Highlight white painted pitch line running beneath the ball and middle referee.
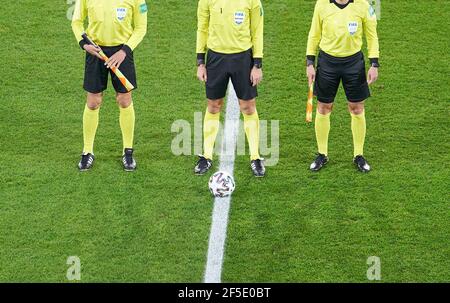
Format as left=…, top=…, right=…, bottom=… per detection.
left=204, top=81, right=240, bottom=283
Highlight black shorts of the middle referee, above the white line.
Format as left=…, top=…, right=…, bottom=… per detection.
left=206, top=49, right=258, bottom=100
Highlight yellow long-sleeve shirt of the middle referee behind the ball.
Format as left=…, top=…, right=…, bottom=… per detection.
left=197, top=0, right=264, bottom=58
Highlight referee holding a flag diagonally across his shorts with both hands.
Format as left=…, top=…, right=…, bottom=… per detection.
left=72, top=0, right=147, bottom=171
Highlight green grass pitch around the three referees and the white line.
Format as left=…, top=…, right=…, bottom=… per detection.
left=0, top=0, right=450, bottom=282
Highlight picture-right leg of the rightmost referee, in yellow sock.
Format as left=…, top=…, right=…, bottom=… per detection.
left=348, top=101, right=366, bottom=157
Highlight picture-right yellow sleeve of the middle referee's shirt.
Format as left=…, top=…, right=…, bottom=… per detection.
left=250, top=0, right=264, bottom=58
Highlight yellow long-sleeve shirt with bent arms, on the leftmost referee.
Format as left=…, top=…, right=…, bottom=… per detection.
left=72, top=0, right=147, bottom=50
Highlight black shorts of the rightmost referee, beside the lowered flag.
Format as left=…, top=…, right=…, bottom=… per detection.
left=314, top=51, right=370, bottom=103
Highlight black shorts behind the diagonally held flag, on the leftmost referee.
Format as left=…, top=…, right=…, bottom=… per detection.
left=83, top=45, right=137, bottom=94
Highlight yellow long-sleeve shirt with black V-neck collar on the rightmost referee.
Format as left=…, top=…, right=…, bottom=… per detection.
left=306, top=0, right=380, bottom=58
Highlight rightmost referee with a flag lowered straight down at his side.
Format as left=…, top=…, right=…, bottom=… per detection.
left=306, top=0, right=379, bottom=172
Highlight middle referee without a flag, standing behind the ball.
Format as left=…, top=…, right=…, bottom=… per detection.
left=194, top=0, right=265, bottom=177
